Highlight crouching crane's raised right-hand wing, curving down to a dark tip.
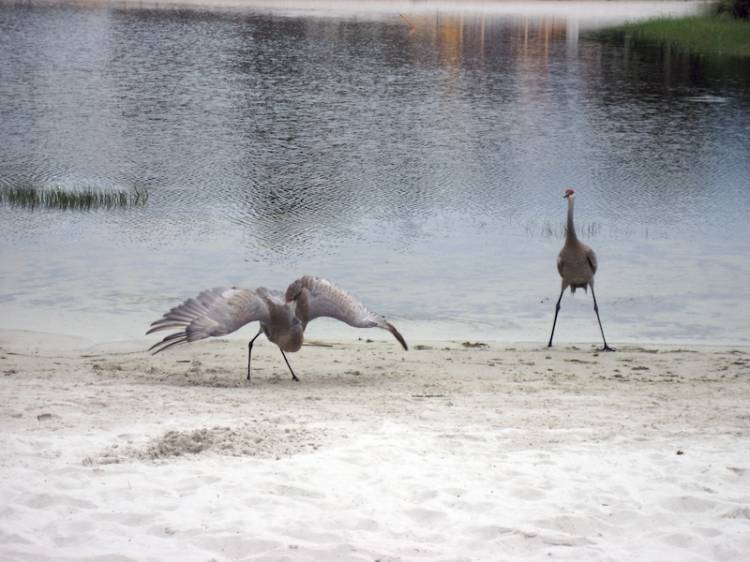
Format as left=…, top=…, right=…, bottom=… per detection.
left=289, top=275, right=409, bottom=349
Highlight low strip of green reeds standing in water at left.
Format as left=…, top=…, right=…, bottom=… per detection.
left=0, top=184, right=148, bottom=211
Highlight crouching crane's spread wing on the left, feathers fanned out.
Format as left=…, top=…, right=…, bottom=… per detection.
left=146, top=287, right=269, bottom=354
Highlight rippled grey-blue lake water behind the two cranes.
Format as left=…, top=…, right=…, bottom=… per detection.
left=0, top=1, right=750, bottom=345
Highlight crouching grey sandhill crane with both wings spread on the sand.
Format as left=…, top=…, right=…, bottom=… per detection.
left=146, top=275, right=409, bottom=381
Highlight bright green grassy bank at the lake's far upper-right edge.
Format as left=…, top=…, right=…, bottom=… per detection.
left=601, top=15, right=750, bottom=57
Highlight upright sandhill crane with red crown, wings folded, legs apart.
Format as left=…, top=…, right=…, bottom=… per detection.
left=547, top=189, right=614, bottom=351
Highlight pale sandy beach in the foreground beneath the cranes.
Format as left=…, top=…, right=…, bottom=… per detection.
left=0, top=338, right=750, bottom=561
